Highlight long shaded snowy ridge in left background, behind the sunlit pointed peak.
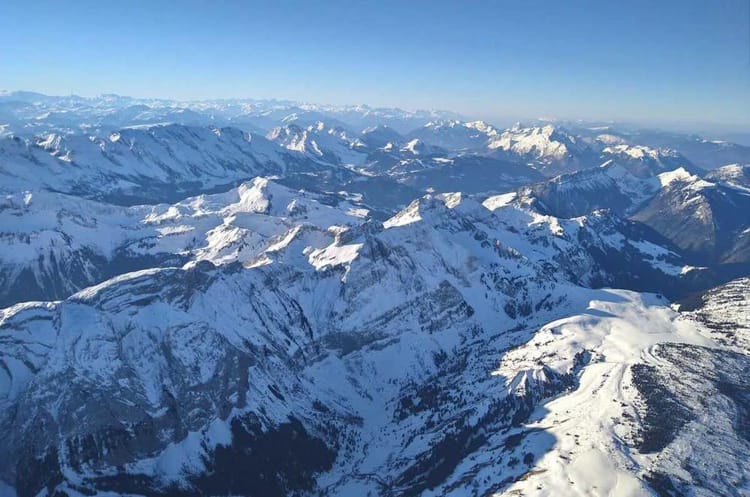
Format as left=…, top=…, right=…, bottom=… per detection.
left=0, top=121, right=426, bottom=218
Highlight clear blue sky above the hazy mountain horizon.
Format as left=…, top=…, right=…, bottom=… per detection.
left=0, top=0, right=750, bottom=126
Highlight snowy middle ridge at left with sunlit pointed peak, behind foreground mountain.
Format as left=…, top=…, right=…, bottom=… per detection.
left=0, top=178, right=368, bottom=307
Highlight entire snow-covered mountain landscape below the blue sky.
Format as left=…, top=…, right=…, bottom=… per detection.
left=0, top=92, right=750, bottom=497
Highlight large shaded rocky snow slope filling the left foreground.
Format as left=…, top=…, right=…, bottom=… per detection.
left=0, top=191, right=596, bottom=495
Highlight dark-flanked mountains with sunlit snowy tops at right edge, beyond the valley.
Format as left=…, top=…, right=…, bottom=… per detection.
left=516, top=161, right=750, bottom=275
